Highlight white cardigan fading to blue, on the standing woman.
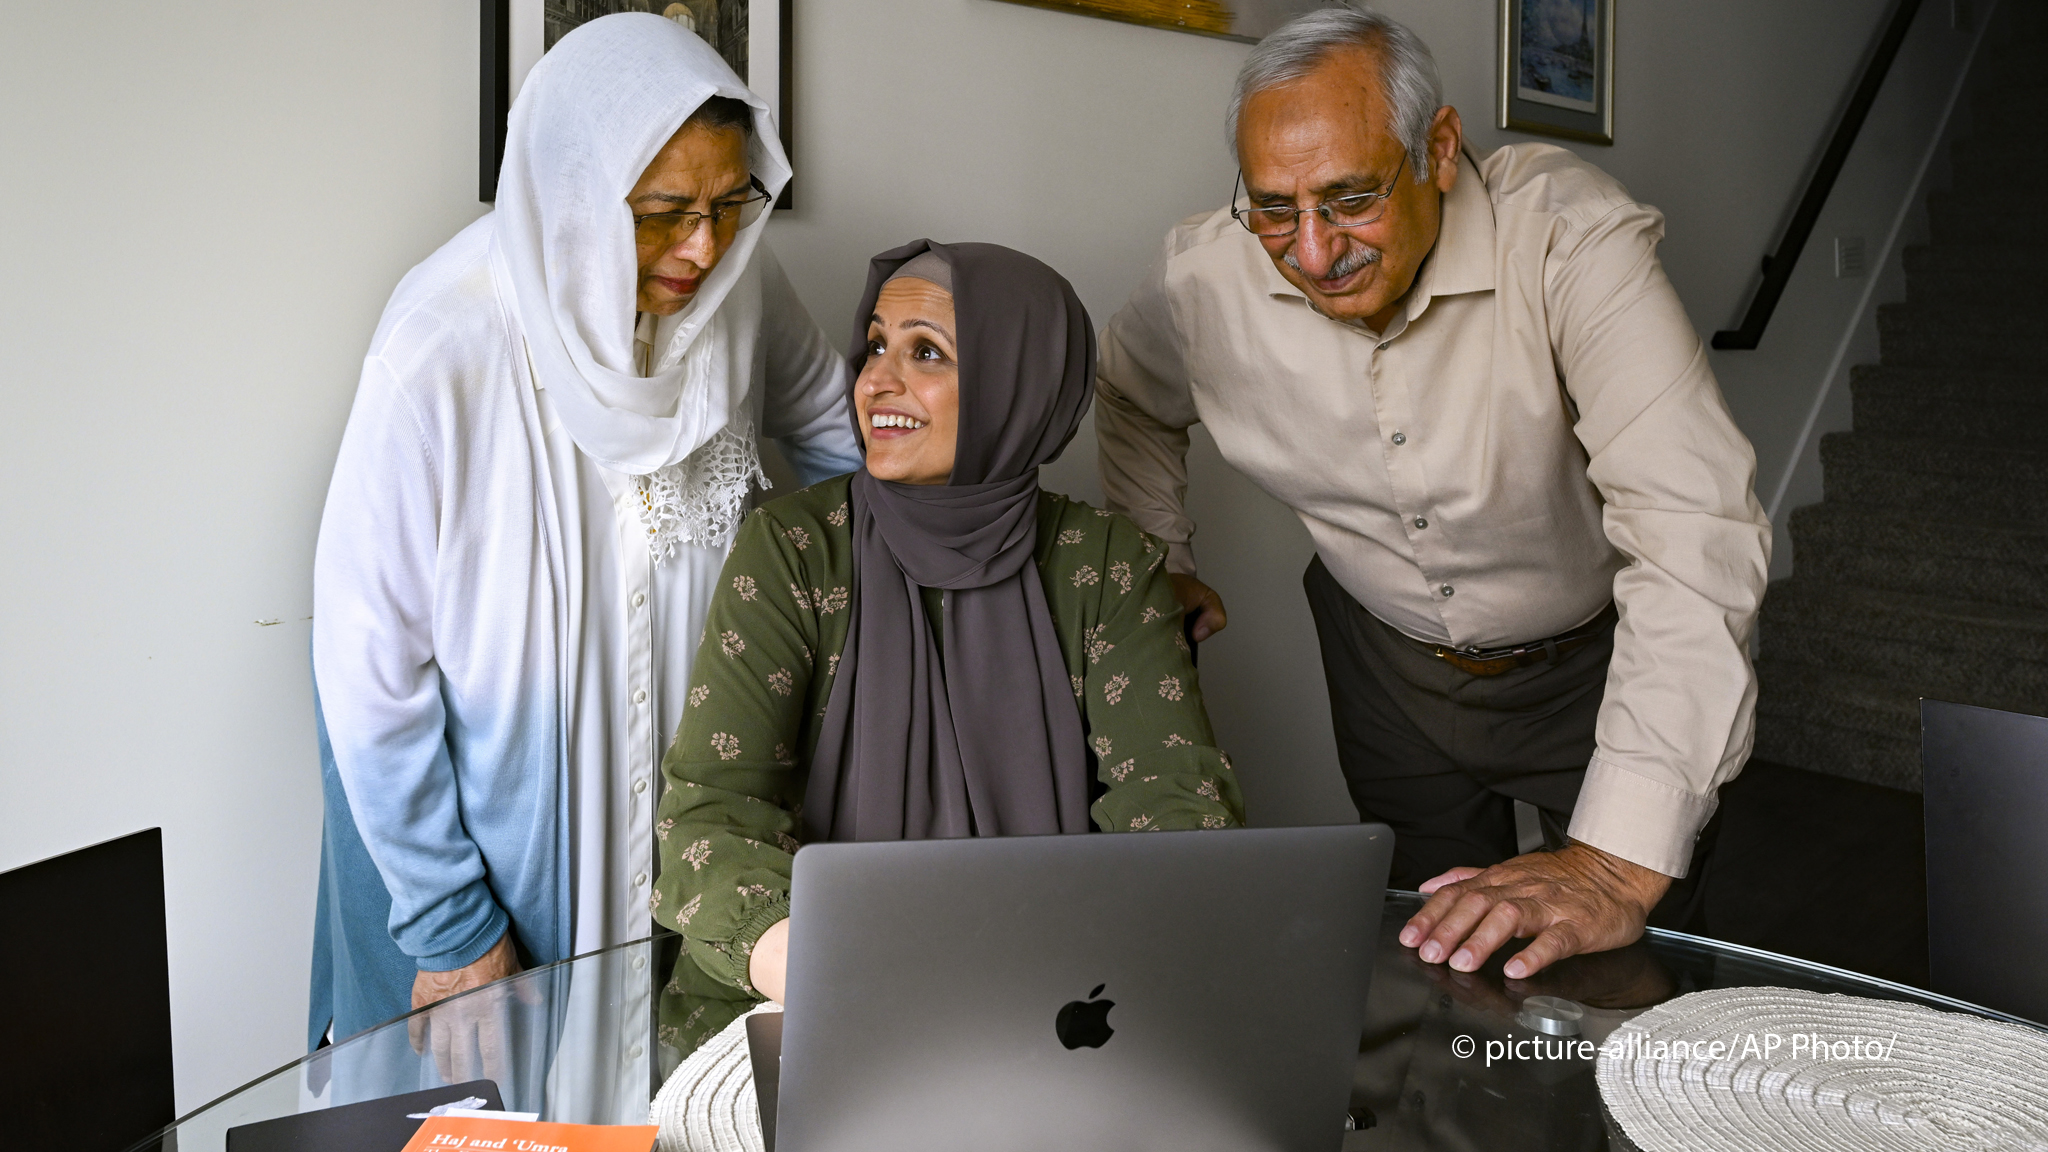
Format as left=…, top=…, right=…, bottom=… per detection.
left=313, top=215, right=860, bottom=1012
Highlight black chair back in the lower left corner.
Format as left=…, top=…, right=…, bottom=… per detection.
left=0, top=828, right=176, bottom=1152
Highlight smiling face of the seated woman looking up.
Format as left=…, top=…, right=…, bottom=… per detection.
left=854, top=277, right=961, bottom=484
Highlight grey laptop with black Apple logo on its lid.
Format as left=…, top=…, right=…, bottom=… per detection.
left=770, top=824, right=1395, bottom=1152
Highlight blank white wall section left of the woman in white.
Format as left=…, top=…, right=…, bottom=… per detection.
left=0, top=0, right=479, bottom=1111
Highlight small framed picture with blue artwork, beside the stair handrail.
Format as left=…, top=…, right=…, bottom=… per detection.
left=1499, top=0, right=1618, bottom=143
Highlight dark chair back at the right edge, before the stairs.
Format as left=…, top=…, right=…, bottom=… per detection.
left=1921, top=701, right=2048, bottom=1023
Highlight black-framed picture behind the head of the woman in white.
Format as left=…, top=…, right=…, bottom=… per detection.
left=477, top=0, right=797, bottom=209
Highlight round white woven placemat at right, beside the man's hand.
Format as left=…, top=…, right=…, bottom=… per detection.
left=1595, top=988, right=2048, bottom=1152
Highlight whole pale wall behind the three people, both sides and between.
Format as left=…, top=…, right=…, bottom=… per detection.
left=0, top=0, right=1966, bottom=1109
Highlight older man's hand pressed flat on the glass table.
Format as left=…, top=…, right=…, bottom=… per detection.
left=1401, top=840, right=1671, bottom=980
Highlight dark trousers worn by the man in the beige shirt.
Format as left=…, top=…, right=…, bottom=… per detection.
left=1303, top=558, right=1716, bottom=929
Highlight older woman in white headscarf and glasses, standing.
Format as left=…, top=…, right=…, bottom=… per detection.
left=309, top=14, right=860, bottom=1043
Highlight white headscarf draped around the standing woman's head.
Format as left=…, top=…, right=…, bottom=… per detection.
left=496, top=12, right=791, bottom=479
